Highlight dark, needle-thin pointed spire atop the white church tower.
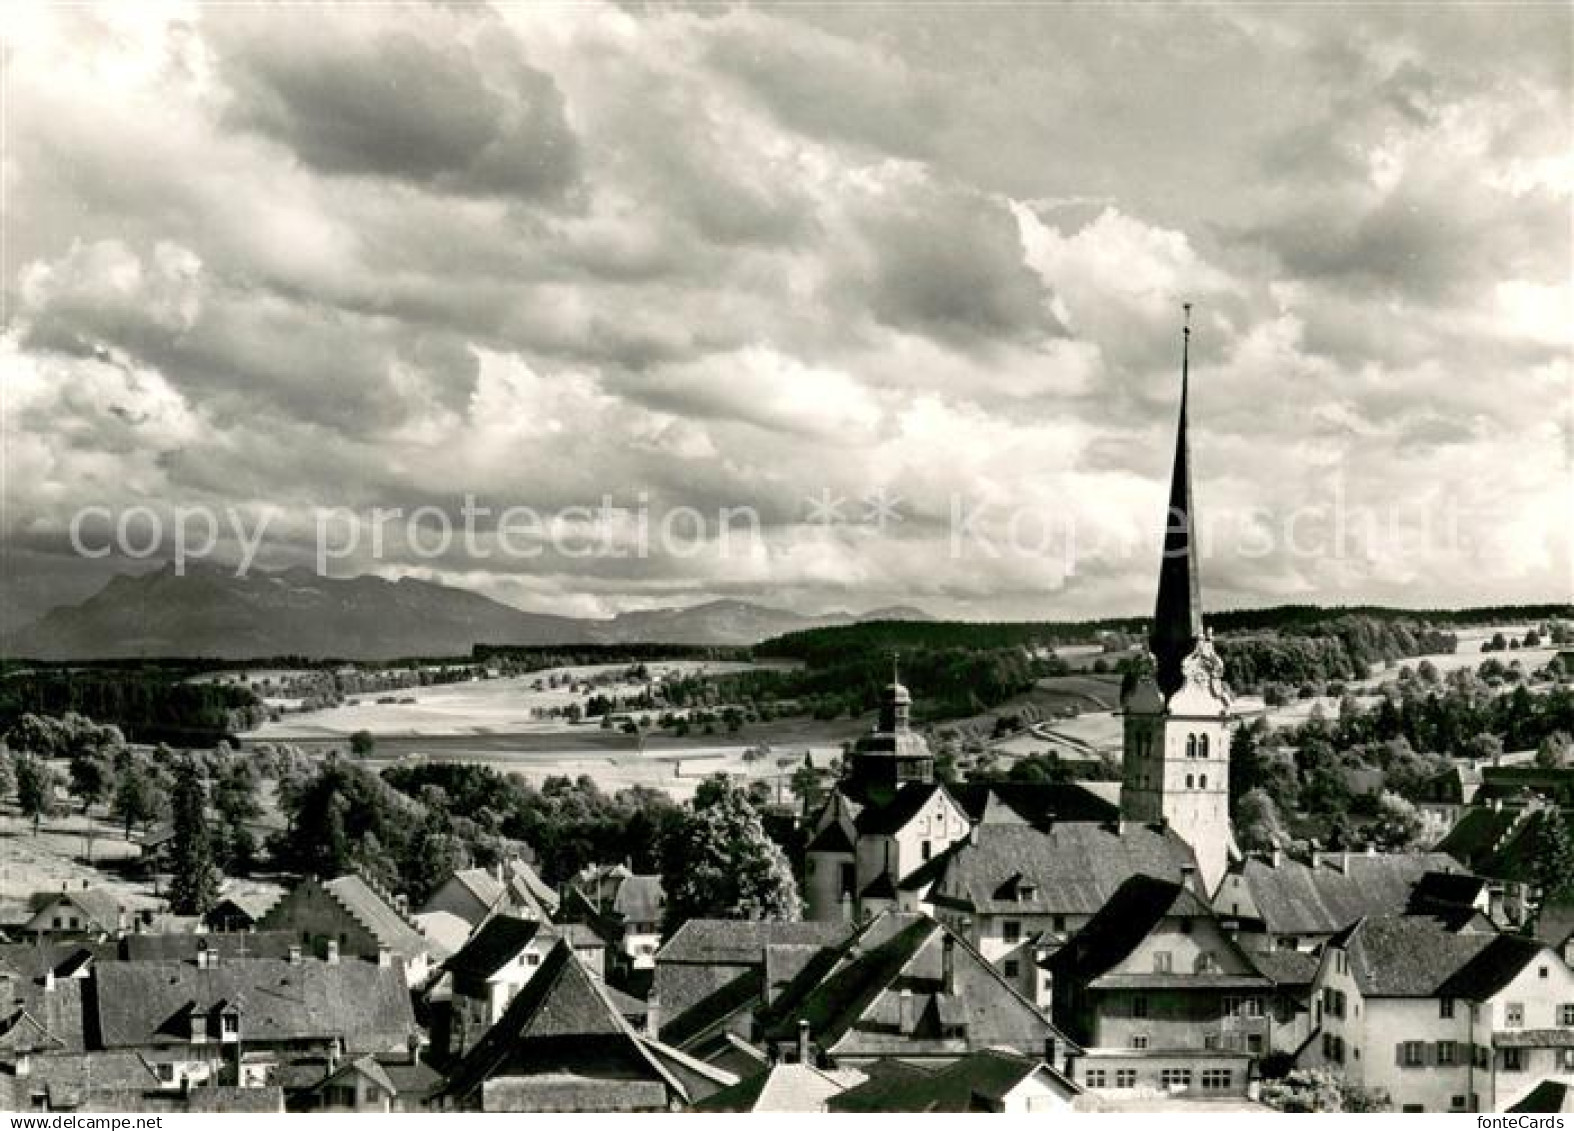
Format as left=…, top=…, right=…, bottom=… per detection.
left=1149, top=302, right=1203, bottom=695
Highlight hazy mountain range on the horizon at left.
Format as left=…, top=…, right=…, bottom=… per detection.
left=5, top=566, right=926, bottom=659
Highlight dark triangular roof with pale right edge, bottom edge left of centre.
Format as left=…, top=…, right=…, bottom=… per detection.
left=444, top=942, right=686, bottom=1100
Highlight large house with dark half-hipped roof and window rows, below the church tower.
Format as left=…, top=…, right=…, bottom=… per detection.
left=1048, top=876, right=1295, bottom=1095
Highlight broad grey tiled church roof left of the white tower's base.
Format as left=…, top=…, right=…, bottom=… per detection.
left=929, top=821, right=1196, bottom=915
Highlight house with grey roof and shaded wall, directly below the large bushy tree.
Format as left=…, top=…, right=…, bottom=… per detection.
left=650, top=919, right=853, bottom=1059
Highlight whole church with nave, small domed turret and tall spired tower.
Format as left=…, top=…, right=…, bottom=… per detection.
left=804, top=311, right=1239, bottom=931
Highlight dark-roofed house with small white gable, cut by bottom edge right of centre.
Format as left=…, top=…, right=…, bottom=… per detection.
left=826, top=1049, right=1081, bottom=1115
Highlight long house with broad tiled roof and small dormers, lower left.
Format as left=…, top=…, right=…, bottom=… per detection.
left=90, top=952, right=419, bottom=1090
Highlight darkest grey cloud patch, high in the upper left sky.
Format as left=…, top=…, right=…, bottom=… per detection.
left=214, top=13, right=579, bottom=200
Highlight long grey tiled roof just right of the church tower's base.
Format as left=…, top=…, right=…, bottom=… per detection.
left=1221, top=853, right=1461, bottom=934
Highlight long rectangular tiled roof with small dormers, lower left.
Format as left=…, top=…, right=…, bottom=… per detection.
left=94, top=958, right=416, bottom=1051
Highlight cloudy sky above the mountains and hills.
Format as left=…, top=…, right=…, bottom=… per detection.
left=0, top=3, right=1574, bottom=621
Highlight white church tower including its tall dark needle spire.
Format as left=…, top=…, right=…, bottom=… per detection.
left=1121, top=304, right=1236, bottom=895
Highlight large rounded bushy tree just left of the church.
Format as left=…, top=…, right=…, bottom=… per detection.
left=661, top=774, right=800, bottom=931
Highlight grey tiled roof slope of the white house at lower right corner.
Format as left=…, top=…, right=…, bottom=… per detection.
left=1328, top=915, right=1502, bottom=997
